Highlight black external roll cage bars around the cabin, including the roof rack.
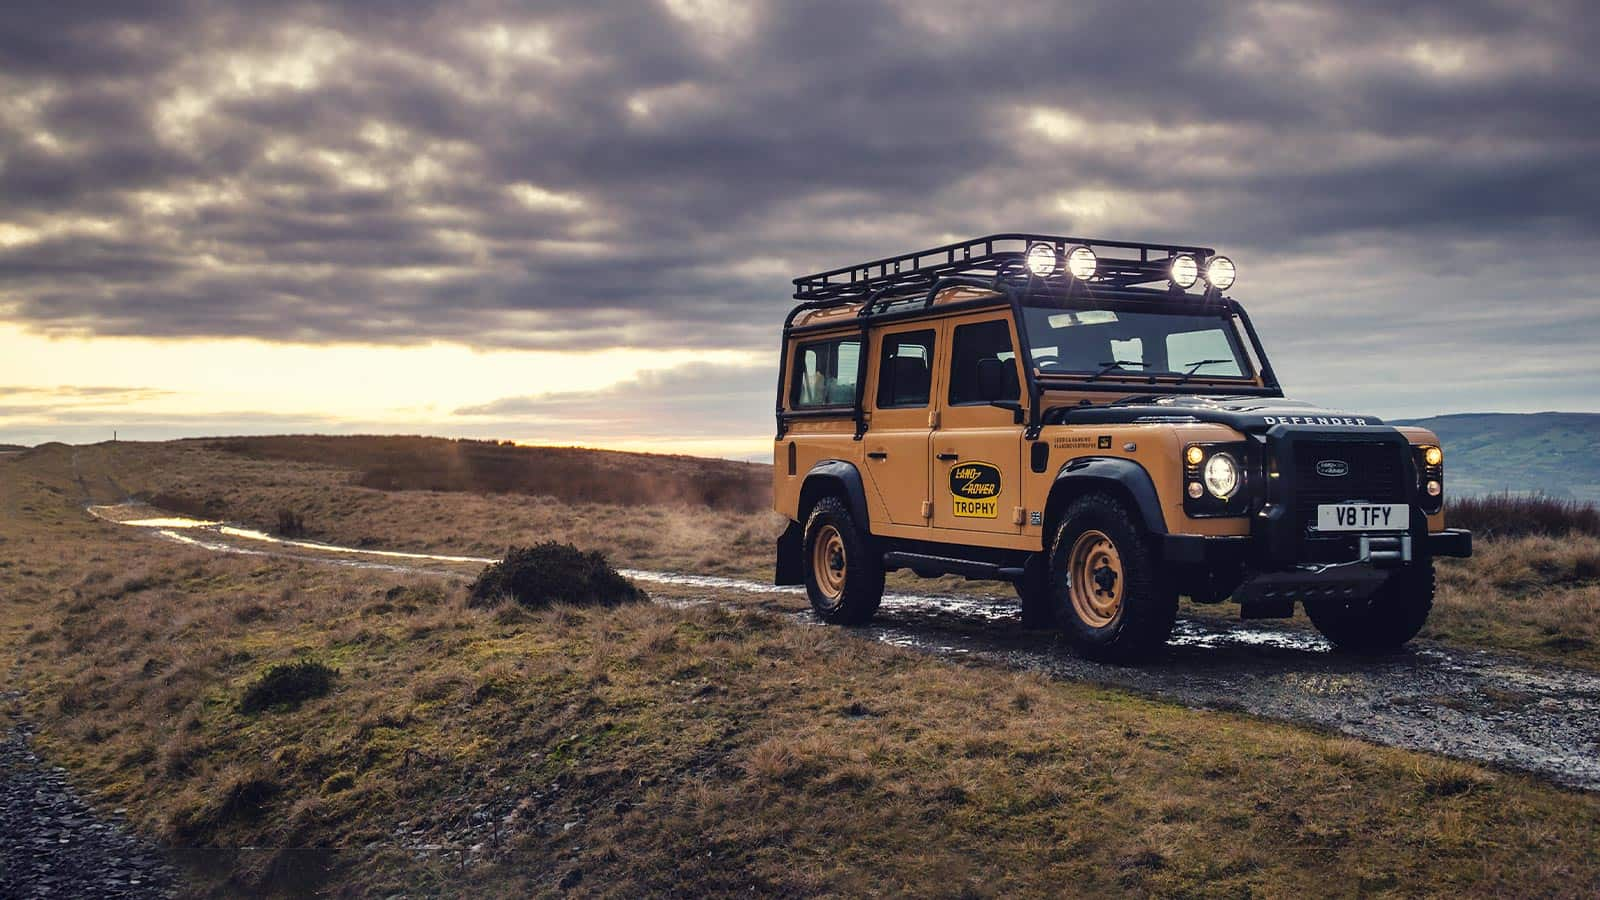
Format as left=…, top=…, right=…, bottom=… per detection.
left=778, top=232, right=1283, bottom=440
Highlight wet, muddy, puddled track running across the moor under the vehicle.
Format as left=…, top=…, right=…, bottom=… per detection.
left=88, top=504, right=1600, bottom=791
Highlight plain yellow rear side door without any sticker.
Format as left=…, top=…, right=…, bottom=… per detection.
left=862, top=322, right=938, bottom=527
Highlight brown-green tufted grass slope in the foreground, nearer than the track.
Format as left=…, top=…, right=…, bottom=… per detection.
left=0, top=447, right=1600, bottom=897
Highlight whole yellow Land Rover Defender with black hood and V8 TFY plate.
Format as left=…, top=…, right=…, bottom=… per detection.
left=773, top=234, right=1472, bottom=658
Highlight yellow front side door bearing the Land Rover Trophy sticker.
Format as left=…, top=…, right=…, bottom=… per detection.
left=930, top=312, right=1022, bottom=535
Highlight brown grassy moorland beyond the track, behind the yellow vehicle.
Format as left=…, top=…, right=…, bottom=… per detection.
left=68, top=437, right=1600, bottom=668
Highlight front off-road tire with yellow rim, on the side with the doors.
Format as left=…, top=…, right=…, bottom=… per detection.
left=1050, top=493, right=1178, bottom=663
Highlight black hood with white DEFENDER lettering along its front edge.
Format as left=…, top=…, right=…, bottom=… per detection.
left=1045, top=396, right=1384, bottom=434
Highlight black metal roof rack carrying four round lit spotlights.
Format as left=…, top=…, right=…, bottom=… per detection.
left=795, top=232, right=1216, bottom=303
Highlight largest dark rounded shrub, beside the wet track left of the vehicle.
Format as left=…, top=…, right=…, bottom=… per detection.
left=467, top=541, right=650, bottom=609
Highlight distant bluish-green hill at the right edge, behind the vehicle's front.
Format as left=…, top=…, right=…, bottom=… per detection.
left=1392, top=413, right=1600, bottom=501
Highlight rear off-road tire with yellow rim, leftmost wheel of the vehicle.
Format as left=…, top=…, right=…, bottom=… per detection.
left=802, top=496, right=883, bottom=625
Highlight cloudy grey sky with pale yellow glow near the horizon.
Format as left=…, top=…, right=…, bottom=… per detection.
left=0, top=0, right=1600, bottom=458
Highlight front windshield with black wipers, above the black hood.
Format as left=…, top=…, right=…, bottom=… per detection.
left=1022, top=307, right=1254, bottom=380
